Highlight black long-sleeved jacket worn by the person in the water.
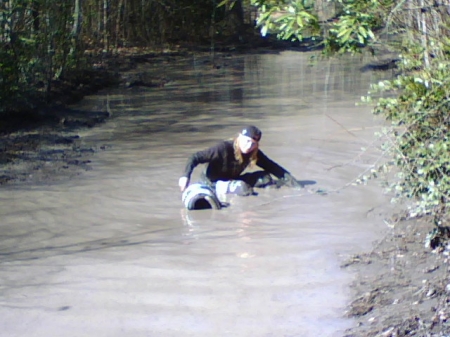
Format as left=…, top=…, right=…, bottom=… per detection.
left=183, top=140, right=289, bottom=182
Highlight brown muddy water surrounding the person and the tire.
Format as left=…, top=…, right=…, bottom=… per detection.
left=0, top=52, right=389, bottom=337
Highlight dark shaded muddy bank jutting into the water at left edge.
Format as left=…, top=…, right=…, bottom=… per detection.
left=0, top=104, right=116, bottom=185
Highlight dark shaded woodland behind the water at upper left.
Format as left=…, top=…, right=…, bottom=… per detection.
left=0, top=0, right=237, bottom=112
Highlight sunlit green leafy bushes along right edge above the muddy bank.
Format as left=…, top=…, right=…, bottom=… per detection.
left=358, top=3, right=450, bottom=225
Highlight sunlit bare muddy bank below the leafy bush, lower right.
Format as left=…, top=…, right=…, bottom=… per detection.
left=342, top=211, right=450, bottom=337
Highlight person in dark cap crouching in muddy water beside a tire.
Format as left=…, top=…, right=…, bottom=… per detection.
left=178, top=125, right=302, bottom=195
